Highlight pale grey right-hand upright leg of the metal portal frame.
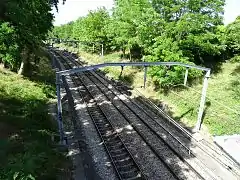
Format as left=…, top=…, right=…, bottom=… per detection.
left=195, top=70, right=210, bottom=131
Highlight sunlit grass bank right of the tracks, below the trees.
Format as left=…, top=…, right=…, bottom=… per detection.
left=58, top=44, right=240, bottom=135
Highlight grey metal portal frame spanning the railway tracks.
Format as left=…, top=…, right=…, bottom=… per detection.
left=54, top=58, right=211, bottom=142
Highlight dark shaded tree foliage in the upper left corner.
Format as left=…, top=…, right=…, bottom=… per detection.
left=0, top=0, right=62, bottom=73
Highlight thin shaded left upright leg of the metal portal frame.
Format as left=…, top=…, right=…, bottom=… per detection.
left=56, top=73, right=64, bottom=144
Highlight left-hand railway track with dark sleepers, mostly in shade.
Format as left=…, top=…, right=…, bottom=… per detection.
left=53, top=49, right=146, bottom=180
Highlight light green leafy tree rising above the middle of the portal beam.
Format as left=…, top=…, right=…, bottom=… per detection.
left=108, top=0, right=155, bottom=57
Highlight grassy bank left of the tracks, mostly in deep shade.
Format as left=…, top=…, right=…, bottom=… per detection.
left=0, top=48, right=66, bottom=180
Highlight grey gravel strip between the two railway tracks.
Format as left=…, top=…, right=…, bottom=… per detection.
left=81, top=75, right=175, bottom=180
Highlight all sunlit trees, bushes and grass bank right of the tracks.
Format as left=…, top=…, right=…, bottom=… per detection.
left=49, top=0, right=240, bottom=135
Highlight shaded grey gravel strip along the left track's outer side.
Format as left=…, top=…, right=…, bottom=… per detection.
left=54, top=52, right=119, bottom=180
